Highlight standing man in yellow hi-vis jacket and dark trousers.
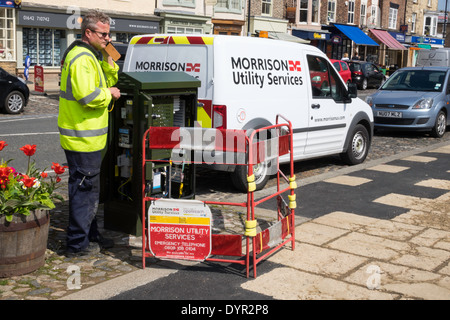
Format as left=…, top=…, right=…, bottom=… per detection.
left=58, top=11, right=120, bottom=256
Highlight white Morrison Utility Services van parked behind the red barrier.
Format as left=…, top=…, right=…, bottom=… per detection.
left=123, top=34, right=373, bottom=190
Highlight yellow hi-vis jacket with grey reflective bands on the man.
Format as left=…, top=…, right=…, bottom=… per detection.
left=58, top=41, right=119, bottom=152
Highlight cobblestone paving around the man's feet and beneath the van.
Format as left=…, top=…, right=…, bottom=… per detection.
left=0, top=95, right=450, bottom=300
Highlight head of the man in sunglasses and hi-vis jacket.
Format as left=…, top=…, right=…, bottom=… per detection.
left=81, top=10, right=111, bottom=51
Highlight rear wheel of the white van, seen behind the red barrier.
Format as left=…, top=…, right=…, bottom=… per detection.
left=231, top=161, right=270, bottom=192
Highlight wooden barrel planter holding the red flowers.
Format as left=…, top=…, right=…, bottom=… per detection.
left=0, top=210, right=50, bottom=278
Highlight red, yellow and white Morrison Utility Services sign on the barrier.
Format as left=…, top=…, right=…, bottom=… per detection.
left=148, top=199, right=211, bottom=261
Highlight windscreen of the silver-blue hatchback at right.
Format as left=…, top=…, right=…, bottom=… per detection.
left=380, top=69, right=446, bottom=91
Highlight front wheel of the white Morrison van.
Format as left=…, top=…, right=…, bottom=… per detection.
left=341, top=124, right=370, bottom=165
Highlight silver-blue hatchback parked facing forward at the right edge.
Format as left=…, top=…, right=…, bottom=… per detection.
left=366, top=67, right=450, bottom=138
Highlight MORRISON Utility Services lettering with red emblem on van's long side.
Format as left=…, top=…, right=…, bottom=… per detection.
left=231, top=57, right=303, bottom=89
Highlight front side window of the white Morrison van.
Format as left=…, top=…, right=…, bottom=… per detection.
left=307, top=55, right=344, bottom=101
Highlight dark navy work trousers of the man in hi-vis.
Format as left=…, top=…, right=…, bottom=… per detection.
left=64, top=150, right=102, bottom=252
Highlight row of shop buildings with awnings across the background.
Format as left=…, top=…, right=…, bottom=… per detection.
left=0, top=0, right=442, bottom=87
